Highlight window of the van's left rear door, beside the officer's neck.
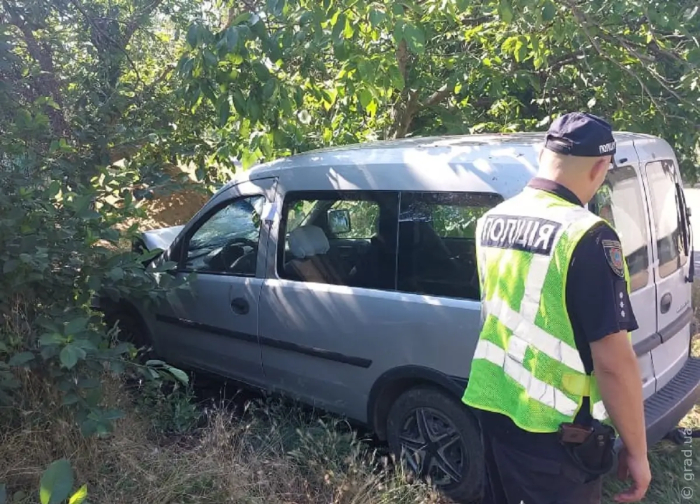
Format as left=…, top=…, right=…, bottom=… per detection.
left=590, top=165, right=649, bottom=291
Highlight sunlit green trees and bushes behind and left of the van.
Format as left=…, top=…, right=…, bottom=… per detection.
left=0, top=0, right=700, bottom=500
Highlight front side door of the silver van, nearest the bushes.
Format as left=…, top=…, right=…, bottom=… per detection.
left=150, top=179, right=275, bottom=385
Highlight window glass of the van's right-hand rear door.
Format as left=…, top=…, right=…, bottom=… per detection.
left=647, top=161, right=688, bottom=278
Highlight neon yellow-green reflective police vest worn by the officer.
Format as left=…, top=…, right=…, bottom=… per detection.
left=463, top=188, right=629, bottom=432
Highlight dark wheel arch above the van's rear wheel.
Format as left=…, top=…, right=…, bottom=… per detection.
left=367, top=366, right=467, bottom=440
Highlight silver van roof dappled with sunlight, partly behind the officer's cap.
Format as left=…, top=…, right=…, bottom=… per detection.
left=222, top=132, right=658, bottom=197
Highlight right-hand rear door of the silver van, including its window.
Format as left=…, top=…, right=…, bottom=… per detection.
left=644, top=158, right=693, bottom=389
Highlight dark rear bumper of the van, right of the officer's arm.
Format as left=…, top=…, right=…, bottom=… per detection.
left=644, top=357, right=700, bottom=446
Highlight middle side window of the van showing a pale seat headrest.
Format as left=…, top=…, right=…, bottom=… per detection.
left=278, top=191, right=399, bottom=290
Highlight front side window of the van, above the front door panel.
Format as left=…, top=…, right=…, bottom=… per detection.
left=183, top=196, right=265, bottom=276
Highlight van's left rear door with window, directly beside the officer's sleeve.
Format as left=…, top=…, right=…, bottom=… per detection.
left=590, top=156, right=658, bottom=399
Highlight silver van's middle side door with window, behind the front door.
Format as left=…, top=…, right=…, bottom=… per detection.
left=260, top=191, right=398, bottom=418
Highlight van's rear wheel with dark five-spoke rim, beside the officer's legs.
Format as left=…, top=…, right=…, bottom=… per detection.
left=387, top=386, right=484, bottom=503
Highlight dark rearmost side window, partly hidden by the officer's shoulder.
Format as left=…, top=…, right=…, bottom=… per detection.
left=397, top=192, right=503, bottom=299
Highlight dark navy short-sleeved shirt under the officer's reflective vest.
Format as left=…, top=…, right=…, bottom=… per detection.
left=480, top=178, right=638, bottom=455
